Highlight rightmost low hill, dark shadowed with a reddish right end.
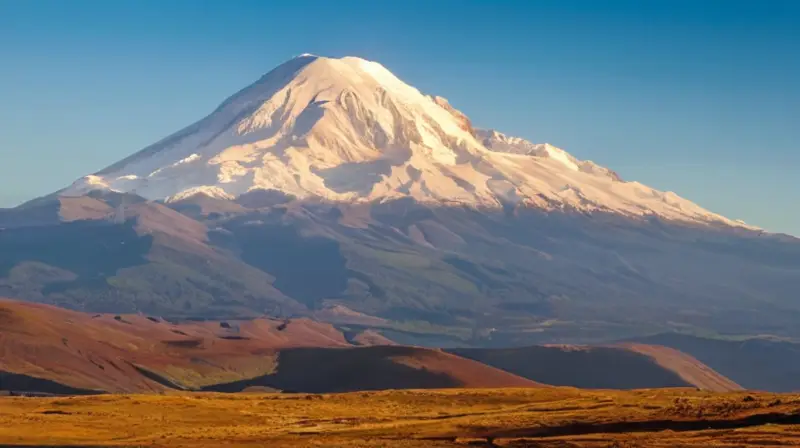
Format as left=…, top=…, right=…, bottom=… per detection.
left=451, top=344, right=741, bottom=391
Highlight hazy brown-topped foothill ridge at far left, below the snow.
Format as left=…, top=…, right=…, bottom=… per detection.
left=0, top=194, right=304, bottom=317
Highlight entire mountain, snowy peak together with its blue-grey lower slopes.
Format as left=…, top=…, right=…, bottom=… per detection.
left=0, top=55, right=800, bottom=347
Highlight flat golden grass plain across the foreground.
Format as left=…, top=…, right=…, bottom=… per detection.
left=0, top=388, right=800, bottom=447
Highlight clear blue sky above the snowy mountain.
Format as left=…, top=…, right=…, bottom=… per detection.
left=0, top=0, right=800, bottom=235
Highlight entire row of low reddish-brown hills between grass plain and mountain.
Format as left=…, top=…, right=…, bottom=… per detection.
left=0, top=300, right=740, bottom=394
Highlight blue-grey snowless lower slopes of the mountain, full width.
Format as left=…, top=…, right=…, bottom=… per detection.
left=0, top=186, right=800, bottom=346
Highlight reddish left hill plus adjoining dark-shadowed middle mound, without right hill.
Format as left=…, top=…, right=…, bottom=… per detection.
left=0, top=300, right=538, bottom=393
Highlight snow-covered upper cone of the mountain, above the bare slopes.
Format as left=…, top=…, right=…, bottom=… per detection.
left=61, top=55, right=745, bottom=227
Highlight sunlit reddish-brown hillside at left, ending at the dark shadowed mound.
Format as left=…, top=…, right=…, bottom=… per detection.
left=0, top=300, right=348, bottom=392
